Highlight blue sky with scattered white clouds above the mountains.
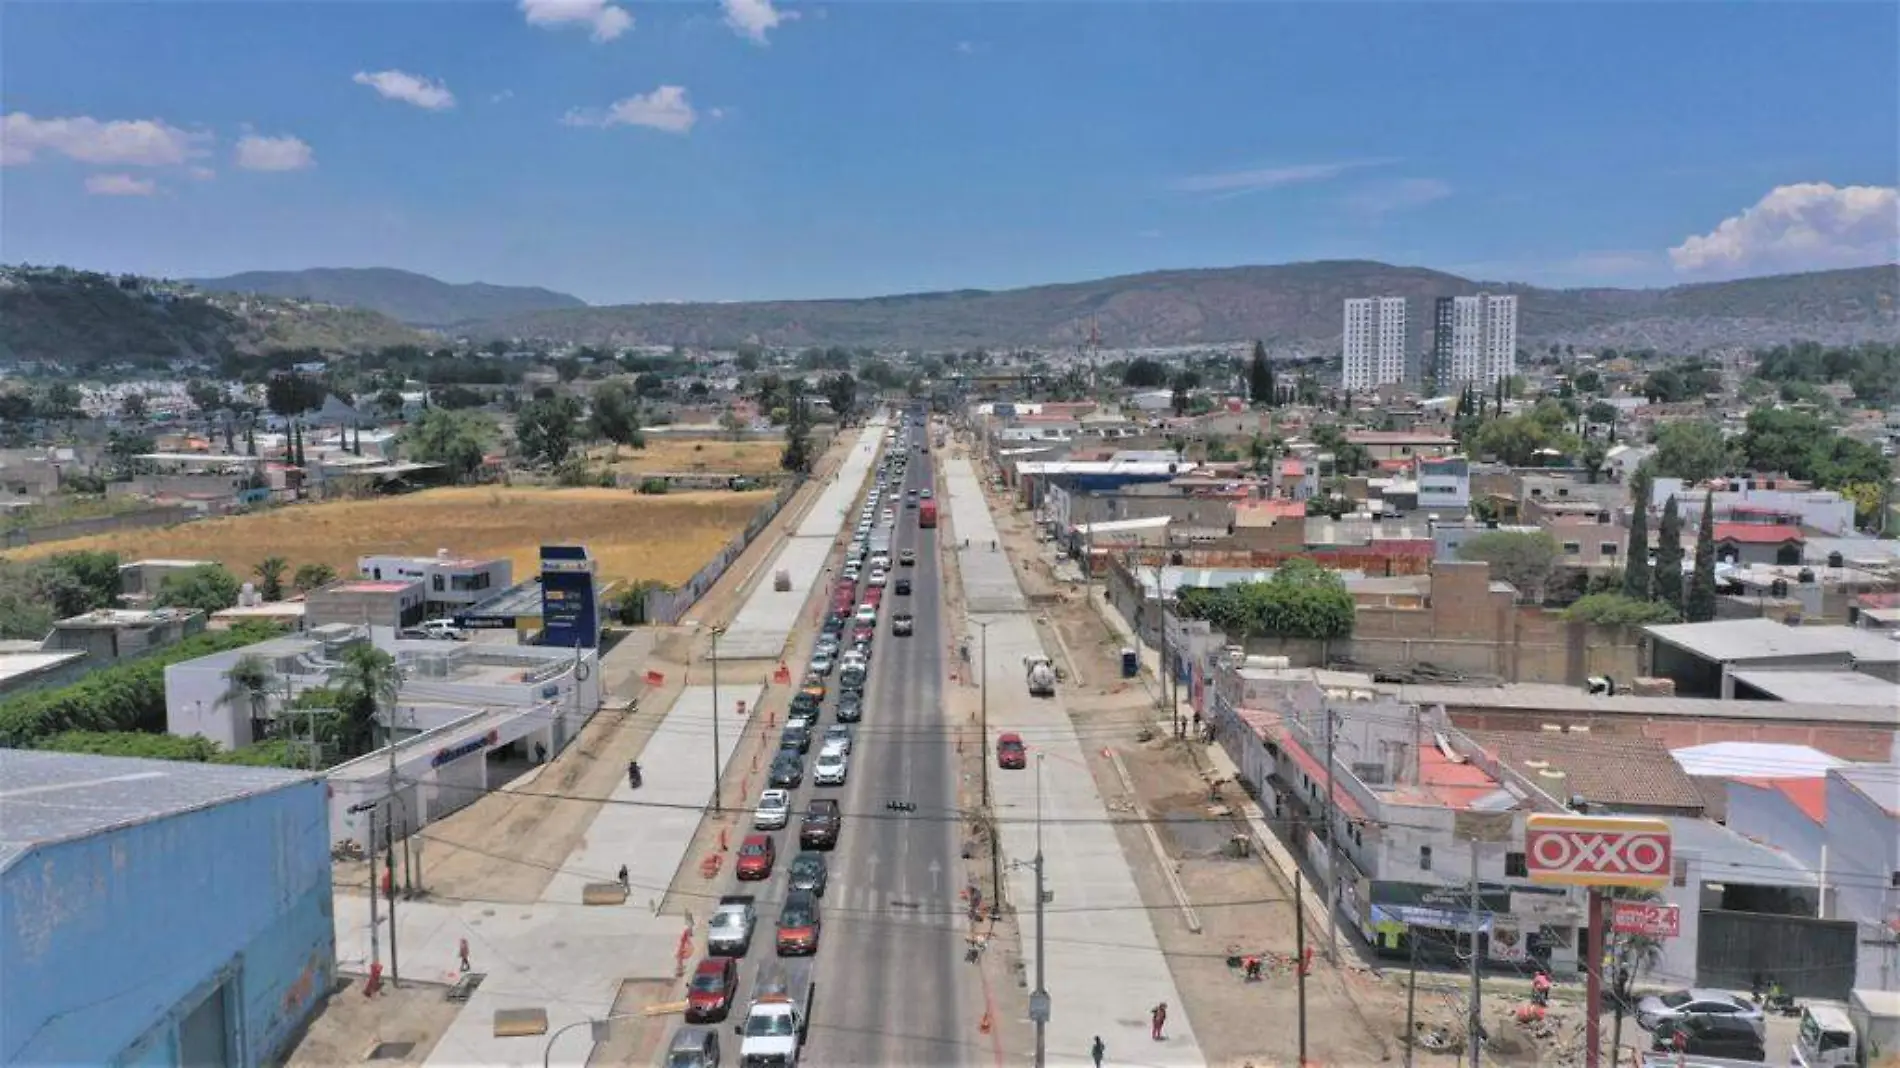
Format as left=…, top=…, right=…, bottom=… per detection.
left=0, top=0, right=1900, bottom=302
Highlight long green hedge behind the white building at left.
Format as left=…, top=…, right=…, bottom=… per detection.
left=0, top=623, right=277, bottom=749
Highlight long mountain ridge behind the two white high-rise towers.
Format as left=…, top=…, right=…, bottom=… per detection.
left=462, top=260, right=1900, bottom=355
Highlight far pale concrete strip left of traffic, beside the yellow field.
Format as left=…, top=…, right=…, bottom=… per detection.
left=718, top=420, right=885, bottom=659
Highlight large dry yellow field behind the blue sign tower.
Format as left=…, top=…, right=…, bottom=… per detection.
left=10, top=486, right=771, bottom=583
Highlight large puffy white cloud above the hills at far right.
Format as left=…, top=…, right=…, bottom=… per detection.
left=1668, top=182, right=1900, bottom=274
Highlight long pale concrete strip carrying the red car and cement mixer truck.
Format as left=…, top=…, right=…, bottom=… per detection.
left=944, top=450, right=1207, bottom=1068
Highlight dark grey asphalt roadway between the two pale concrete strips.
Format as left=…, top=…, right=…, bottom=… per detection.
left=720, top=414, right=986, bottom=1068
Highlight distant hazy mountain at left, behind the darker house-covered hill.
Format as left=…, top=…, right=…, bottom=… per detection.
left=188, top=268, right=587, bottom=327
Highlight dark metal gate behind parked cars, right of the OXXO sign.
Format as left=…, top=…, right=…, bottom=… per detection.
left=1695, top=908, right=1860, bottom=1001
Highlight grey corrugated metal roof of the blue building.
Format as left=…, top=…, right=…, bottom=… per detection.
left=0, top=749, right=314, bottom=870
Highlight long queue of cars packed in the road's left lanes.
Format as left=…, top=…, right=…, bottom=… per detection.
left=667, top=416, right=931, bottom=1068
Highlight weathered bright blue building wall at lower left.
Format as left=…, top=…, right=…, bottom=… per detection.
left=0, top=781, right=336, bottom=1066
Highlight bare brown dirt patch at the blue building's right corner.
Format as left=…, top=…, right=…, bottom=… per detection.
left=285, top=979, right=462, bottom=1068
